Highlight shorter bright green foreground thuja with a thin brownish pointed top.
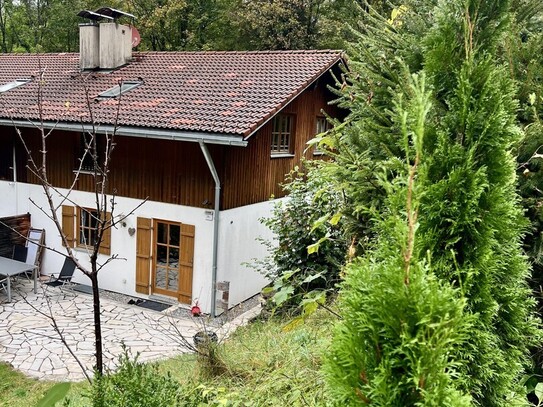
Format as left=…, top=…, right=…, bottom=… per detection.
left=325, top=76, right=471, bottom=407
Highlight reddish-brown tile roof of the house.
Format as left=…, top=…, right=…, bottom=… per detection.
left=0, top=51, right=341, bottom=136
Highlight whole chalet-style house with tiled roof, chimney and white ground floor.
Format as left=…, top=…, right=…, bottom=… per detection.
left=0, top=18, right=342, bottom=312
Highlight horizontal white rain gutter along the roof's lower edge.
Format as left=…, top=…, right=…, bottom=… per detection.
left=0, top=119, right=247, bottom=147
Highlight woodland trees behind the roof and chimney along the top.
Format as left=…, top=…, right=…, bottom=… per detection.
left=0, top=0, right=396, bottom=52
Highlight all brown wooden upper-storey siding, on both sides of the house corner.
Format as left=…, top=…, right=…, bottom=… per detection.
left=12, top=76, right=338, bottom=209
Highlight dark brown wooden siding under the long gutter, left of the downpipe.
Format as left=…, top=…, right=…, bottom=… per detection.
left=20, top=131, right=223, bottom=208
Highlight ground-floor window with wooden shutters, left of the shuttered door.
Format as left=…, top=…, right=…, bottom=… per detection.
left=62, top=205, right=111, bottom=255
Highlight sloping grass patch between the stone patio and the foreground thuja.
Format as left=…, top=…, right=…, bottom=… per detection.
left=161, top=312, right=334, bottom=407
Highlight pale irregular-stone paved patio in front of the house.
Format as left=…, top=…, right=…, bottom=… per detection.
left=0, top=282, right=257, bottom=381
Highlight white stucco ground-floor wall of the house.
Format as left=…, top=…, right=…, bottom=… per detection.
left=0, top=181, right=278, bottom=312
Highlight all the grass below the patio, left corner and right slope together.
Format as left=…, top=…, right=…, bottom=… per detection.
left=0, top=311, right=335, bottom=407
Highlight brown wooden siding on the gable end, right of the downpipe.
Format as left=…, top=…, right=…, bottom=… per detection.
left=222, top=81, right=337, bottom=209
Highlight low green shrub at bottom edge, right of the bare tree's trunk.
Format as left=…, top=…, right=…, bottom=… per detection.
left=89, top=345, right=184, bottom=407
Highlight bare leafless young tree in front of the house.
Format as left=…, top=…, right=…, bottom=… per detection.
left=9, top=66, right=146, bottom=375
